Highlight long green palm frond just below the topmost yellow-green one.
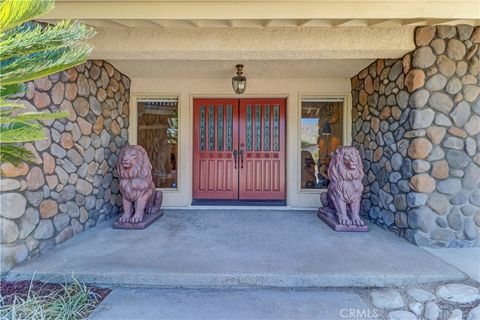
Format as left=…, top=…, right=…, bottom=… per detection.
left=0, top=20, right=95, bottom=60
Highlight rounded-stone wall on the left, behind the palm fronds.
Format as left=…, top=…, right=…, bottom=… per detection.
left=0, top=60, right=130, bottom=273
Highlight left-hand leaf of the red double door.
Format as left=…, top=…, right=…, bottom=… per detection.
left=193, top=99, right=238, bottom=199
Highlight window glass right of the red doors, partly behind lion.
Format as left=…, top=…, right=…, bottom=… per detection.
left=300, top=98, right=344, bottom=189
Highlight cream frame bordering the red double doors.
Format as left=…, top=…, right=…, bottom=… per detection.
left=189, top=93, right=288, bottom=202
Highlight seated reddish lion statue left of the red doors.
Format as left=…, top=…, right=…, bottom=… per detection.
left=117, top=145, right=162, bottom=224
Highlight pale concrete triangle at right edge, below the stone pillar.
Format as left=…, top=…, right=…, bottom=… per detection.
left=422, top=247, right=480, bottom=282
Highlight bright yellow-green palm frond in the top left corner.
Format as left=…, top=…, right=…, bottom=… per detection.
left=0, top=0, right=55, bottom=32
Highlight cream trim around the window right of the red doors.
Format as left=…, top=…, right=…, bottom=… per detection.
left=295, top=93, right=352, bottom=194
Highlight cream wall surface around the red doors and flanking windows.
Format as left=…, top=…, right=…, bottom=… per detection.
left=130, top=78, right=351, bottom=207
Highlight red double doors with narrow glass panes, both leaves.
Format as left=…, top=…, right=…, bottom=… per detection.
left=193, top=99, right=285, bottom=200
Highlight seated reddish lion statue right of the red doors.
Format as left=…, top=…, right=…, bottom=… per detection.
left=320, top=146, right=365, bottom=226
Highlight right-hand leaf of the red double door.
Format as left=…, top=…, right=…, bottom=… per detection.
left=239, top=99, right=285, bottom=200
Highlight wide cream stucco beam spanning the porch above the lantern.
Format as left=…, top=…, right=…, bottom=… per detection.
left=88, top=26, right=414, bottom=61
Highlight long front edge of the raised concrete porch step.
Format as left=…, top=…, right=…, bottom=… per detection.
left=7, top=270, right=465, bottom=289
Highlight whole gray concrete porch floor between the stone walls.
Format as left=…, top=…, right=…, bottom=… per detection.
left=8, top=210, right=465, bottom=288
